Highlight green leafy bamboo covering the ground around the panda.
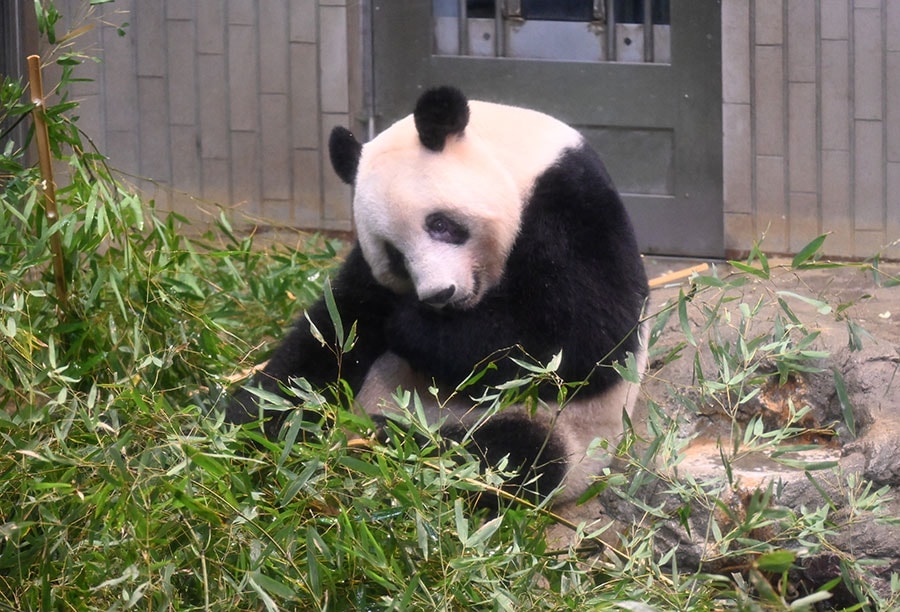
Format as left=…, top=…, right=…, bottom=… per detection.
left=0, top=3, right=900, bottom=610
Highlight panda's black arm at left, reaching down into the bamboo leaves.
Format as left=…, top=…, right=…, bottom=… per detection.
left=226, top=245, right=394, bottom=433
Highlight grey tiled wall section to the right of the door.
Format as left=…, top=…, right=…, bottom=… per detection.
left=722, top=0, right=900, bottom=258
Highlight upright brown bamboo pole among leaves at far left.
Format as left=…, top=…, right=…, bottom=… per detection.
left=28, top=55, right=68, bottom=310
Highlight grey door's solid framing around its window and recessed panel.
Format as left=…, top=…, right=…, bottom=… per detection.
left=371, top=0, right=724, bottom=257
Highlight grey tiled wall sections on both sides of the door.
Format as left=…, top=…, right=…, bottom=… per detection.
left=40, top=0, right=900, bottom=258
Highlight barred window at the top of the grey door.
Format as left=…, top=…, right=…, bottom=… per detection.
left=432, top=0, right=671, bottom=64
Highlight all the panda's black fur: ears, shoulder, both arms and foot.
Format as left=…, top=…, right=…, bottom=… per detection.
left=226, top=90, right=648, bottom=504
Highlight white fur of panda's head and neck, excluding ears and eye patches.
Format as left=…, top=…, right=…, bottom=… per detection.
left=353, top=101, right=581, bottom=307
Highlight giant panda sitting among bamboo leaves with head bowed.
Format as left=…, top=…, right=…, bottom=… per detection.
left=226, top=87, right=648, bottom=503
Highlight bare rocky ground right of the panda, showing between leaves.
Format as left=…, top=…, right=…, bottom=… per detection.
left=552, top=257, right=900, bottom=592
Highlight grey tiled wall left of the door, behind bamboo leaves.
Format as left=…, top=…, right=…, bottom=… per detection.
left=51, top=0, right=361, bottom=231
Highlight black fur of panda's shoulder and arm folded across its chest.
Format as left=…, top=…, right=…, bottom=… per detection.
left=386, top=146, right=648, bottom=399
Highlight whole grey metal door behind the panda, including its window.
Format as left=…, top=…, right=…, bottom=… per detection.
left=370, top=0, right=723, bottom=256
